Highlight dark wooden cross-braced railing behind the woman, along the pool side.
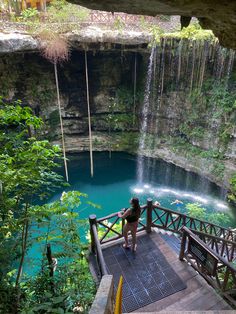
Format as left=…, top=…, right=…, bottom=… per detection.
left=91, top=199, right=236, bottom=248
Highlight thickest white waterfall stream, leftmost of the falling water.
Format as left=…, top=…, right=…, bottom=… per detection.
left=137, top=48, right=156, bottom=183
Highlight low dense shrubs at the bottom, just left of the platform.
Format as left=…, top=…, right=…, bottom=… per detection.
left=21, top=258, right=96, bottom=314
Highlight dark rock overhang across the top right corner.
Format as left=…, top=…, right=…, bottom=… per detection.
left=68, top=0, right=236, bottom=49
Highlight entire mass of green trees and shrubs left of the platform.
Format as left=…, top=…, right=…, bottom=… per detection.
left=0, top=98, right=95, bottom=313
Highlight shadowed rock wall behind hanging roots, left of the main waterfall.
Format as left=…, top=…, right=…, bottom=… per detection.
left=0, top=49, right=148, bottom=152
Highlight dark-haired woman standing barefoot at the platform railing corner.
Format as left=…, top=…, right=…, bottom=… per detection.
left=118, top=197, right=141, bottom=252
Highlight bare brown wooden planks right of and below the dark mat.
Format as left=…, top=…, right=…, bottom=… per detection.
left=102, top=232, right=233, bottom=314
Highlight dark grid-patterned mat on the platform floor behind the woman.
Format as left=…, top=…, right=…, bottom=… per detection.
left=103, top=235, right=187, bottom=312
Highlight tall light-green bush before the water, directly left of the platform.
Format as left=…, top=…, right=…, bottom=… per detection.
left=23, top=191, right=95, bottom=313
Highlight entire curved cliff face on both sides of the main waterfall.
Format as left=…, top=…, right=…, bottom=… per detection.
left=0, top=36, right=236, bottom=187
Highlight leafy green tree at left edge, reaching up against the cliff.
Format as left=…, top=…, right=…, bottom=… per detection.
left=0, top=98, right=63, bottom=310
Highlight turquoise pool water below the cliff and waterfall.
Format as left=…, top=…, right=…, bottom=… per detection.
left=25, top=152, right=236, bottom=274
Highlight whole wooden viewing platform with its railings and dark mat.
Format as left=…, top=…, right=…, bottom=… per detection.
left=90, top=200, right=236, bottom=314
